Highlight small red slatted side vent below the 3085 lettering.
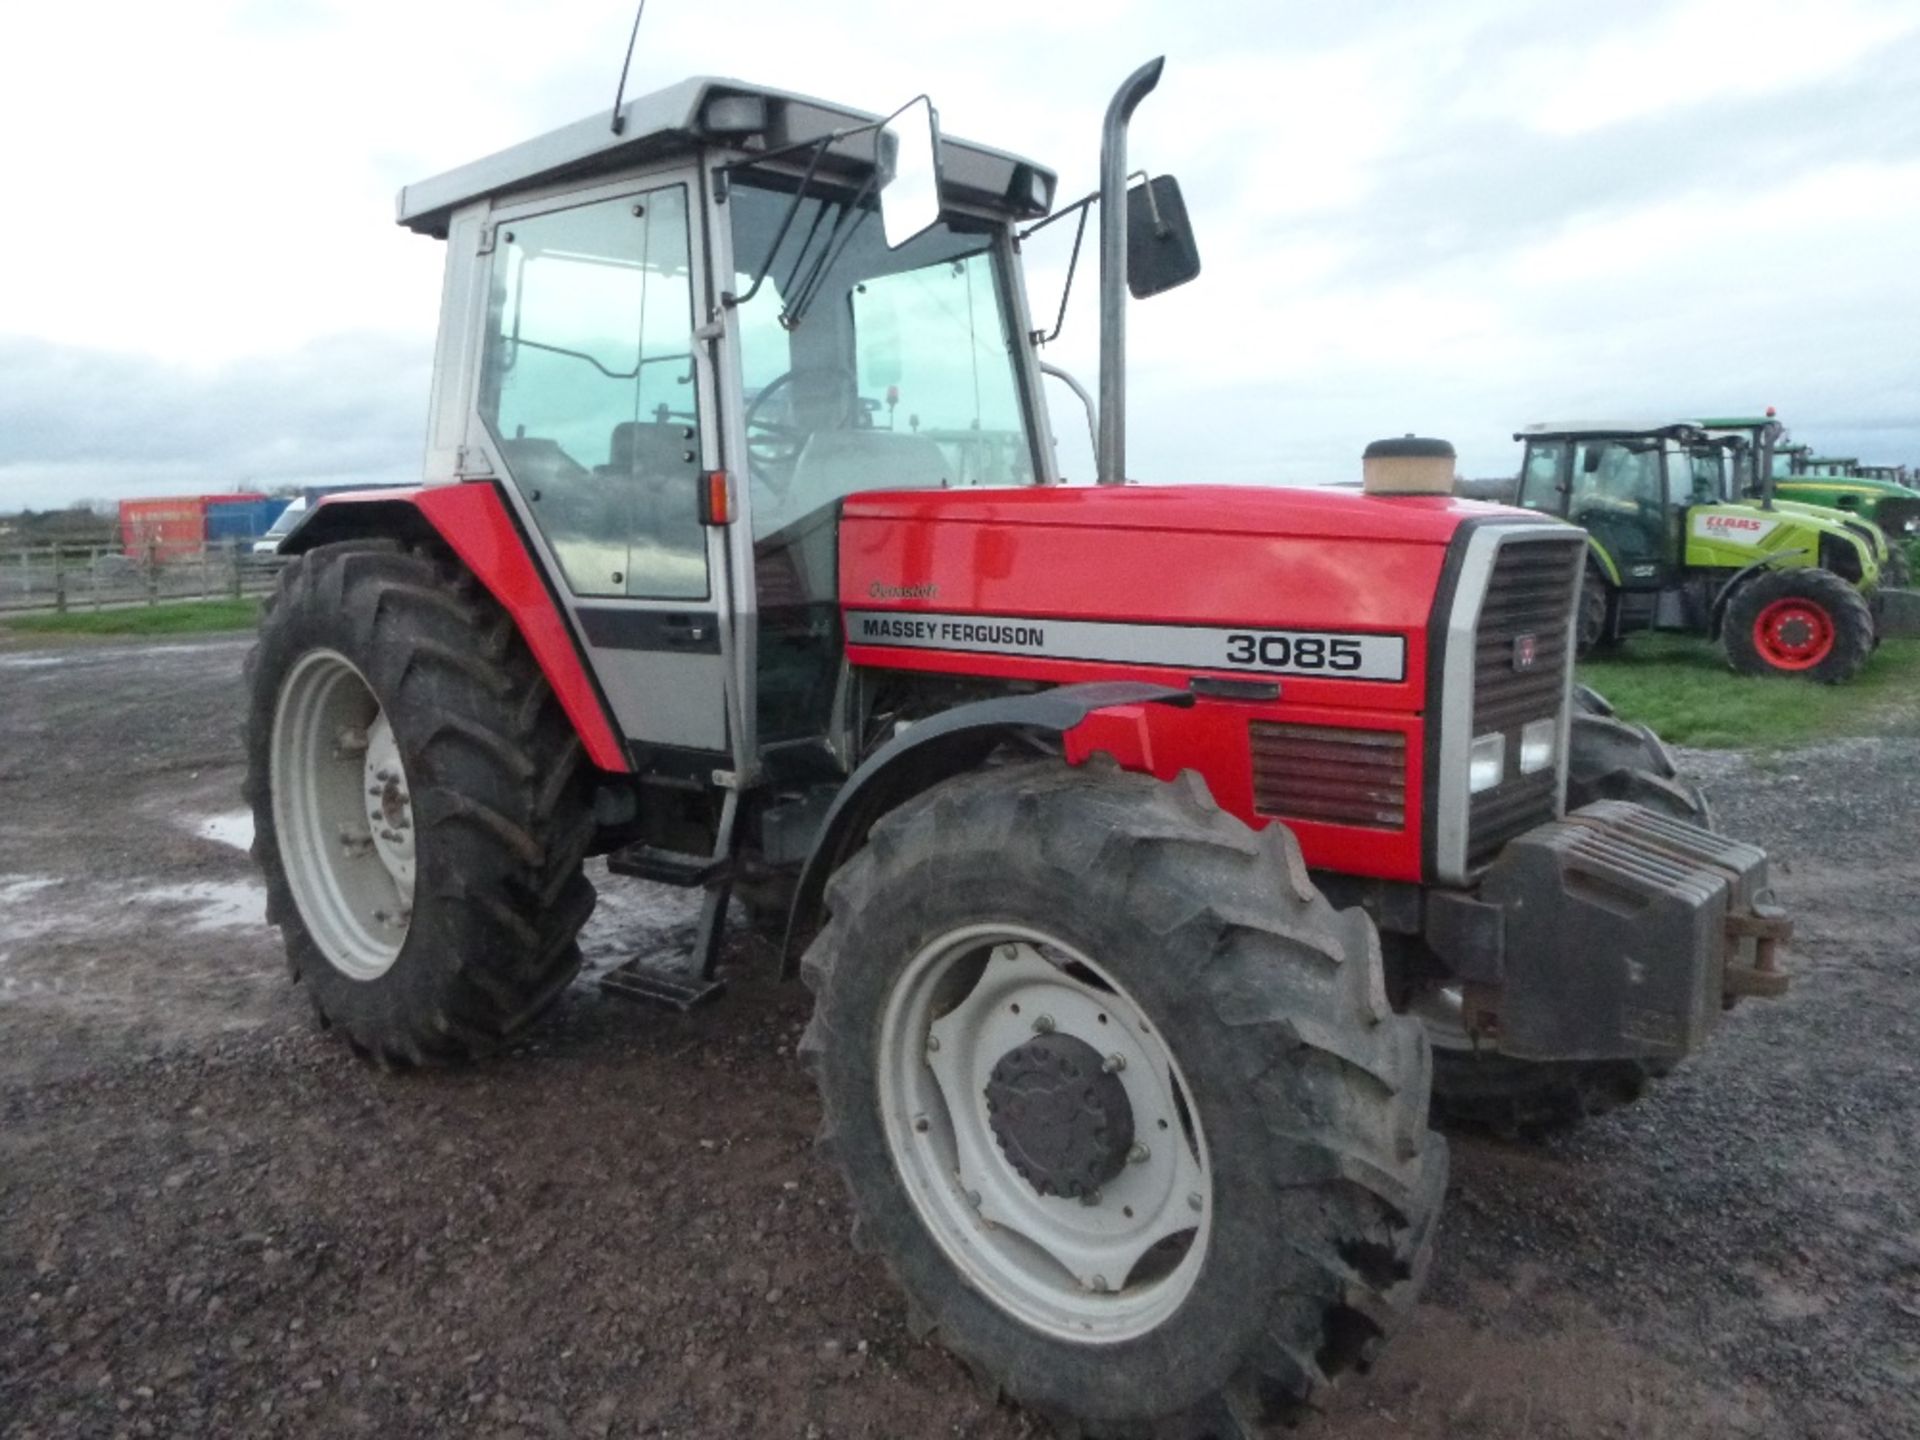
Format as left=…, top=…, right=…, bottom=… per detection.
left=1248, top=720, right=1407, bottom=829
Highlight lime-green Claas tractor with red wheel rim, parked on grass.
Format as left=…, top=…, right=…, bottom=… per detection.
left=1515, top=420, right=1882, bottom=684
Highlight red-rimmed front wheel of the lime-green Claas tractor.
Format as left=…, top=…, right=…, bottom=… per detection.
left=1722, top=570, right=1874, bottom=685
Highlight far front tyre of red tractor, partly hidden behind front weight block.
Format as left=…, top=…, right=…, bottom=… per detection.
left=1423, top=685, right=1713, bottom=1140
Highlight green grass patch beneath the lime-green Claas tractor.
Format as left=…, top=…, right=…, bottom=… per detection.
left=1580, top=636, right=1920, bottom=749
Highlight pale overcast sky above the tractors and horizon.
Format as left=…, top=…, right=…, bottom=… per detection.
left=0, top=0, right=1920, bottom=509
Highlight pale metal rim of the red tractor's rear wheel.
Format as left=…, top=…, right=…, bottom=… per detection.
left=271, top=651, right=415, bottom=979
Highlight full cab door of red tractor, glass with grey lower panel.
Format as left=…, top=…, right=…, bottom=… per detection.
left=474, top=169, right=730, bottom=753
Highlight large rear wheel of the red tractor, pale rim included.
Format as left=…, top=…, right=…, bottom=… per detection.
left=246, top=541, right=593, bottom=1064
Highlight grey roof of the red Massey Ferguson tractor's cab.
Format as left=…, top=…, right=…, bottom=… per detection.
left=396, top=75, right=1056, bottom=240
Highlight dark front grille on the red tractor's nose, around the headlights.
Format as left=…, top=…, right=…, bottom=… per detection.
left=1467, top=534, right=1586, bottom=866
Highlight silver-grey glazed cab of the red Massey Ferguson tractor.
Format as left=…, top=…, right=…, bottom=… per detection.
left=384, top=79, right=1190, bottom=776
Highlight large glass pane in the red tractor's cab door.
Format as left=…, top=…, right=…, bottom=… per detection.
left=480, top=184, right=708, bottom=599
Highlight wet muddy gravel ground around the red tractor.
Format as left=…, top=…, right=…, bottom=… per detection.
left=0, top=639, right=1920, bottom=1440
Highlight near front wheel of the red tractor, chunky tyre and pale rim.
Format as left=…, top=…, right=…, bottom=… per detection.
left=803, top=762, right=1446, bottom=1440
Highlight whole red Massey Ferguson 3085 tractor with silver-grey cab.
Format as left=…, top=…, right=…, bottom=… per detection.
left=250, top=61, right=1786, bottom=1436
